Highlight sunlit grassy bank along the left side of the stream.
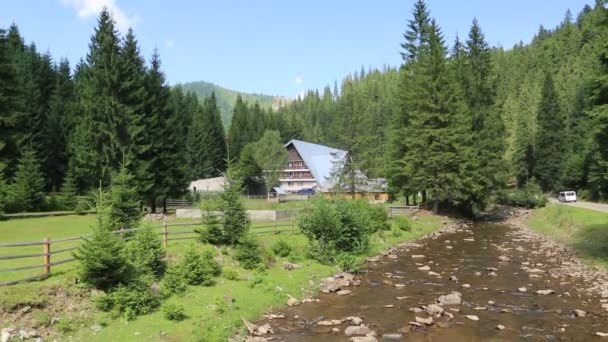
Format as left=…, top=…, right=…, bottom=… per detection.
left=0, top=213, right=443, bottom=341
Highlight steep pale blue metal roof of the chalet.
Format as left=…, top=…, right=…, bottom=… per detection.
left=285, top=139, right=348, bottom=191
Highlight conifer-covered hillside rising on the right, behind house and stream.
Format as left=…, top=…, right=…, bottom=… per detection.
left=230, top=0, right=608, bottom=208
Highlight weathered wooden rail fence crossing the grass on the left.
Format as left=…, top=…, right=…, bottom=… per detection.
left=0, top=217, right=296, bottom=286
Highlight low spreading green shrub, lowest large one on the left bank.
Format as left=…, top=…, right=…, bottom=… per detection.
left=110, top=279, right=160, bottom=321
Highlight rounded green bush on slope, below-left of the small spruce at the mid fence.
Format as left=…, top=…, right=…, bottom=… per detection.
left=180, top=245, right=222, bottom=286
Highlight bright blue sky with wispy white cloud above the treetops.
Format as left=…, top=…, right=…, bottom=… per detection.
left=0, top=0, right=592, bottom=97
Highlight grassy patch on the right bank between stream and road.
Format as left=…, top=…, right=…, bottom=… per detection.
left=527, top=204, right=608, bottom=267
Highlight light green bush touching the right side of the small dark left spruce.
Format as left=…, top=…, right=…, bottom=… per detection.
left=125, top=227, right=167, bottom=277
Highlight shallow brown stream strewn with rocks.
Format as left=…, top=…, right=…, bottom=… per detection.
left=251, top=211, right=608, bottom=342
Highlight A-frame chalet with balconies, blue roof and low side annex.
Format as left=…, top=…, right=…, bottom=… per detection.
left=279, top=140, right=388, bottom=202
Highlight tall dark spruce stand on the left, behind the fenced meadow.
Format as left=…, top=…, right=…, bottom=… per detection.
left=0, top=9, right=226, bottom=212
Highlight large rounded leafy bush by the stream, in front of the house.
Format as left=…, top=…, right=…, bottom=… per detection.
left=298, top=197, right=374, bottom=260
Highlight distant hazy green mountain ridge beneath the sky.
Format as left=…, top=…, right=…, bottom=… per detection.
left=178, top=81, right=292, bottom=128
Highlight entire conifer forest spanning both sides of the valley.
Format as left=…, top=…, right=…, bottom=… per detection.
left=0, top=0, right=608, bottom=212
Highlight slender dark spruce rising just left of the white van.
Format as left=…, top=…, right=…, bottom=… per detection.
left=534, top=72, right=564, bottom=191
